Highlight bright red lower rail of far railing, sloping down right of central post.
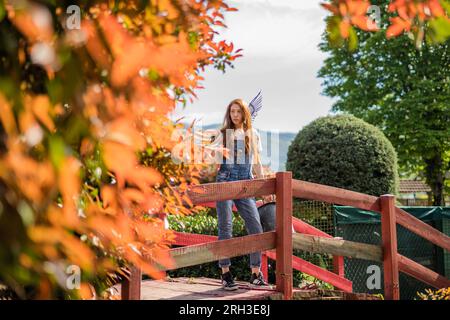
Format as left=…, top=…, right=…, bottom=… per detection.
left=267, top=251, right=353, bottom=292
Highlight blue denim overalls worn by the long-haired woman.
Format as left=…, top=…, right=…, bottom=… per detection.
left=216, top=140, right=263, bottom=268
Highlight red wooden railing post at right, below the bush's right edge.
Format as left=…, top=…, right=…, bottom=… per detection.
left=380, top=194, right=400, bottom=300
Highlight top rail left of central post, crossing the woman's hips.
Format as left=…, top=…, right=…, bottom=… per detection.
left=186, top=178, right=275, bottom=204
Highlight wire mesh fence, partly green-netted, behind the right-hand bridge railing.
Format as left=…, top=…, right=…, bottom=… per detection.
left=293, top=199, right=450, bottom=300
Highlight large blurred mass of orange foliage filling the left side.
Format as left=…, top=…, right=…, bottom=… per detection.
left=0, top=0, right=240, bottom=299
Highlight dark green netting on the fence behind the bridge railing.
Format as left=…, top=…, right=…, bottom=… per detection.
left=334, top=206, right=450, bottom=299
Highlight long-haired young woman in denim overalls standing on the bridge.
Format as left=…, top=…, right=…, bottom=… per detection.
left=209, top=99, right=272, bottom=290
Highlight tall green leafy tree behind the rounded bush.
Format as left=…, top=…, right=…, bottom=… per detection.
left=318, top=1, right=450, bottom=205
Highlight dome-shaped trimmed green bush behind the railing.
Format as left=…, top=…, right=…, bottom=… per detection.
left=286, top=115, right=398, bottom=196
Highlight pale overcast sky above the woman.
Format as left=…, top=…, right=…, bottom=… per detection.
left=169, top=0, right=332, bottom=132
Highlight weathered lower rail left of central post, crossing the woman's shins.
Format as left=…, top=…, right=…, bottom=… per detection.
left=160, top=231, right=276, bottom=270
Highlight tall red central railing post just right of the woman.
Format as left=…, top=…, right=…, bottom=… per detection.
left=275, top=172, right=293, bottom=300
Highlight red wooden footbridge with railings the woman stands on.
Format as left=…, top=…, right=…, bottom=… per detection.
left=121, top=172, right=450, bottom=300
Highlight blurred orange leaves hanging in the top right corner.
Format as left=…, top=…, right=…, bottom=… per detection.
left=321, top=0, right=450, bottom=51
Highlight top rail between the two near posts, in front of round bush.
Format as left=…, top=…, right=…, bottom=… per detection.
left=292, top=179, right=380, bottom=212
